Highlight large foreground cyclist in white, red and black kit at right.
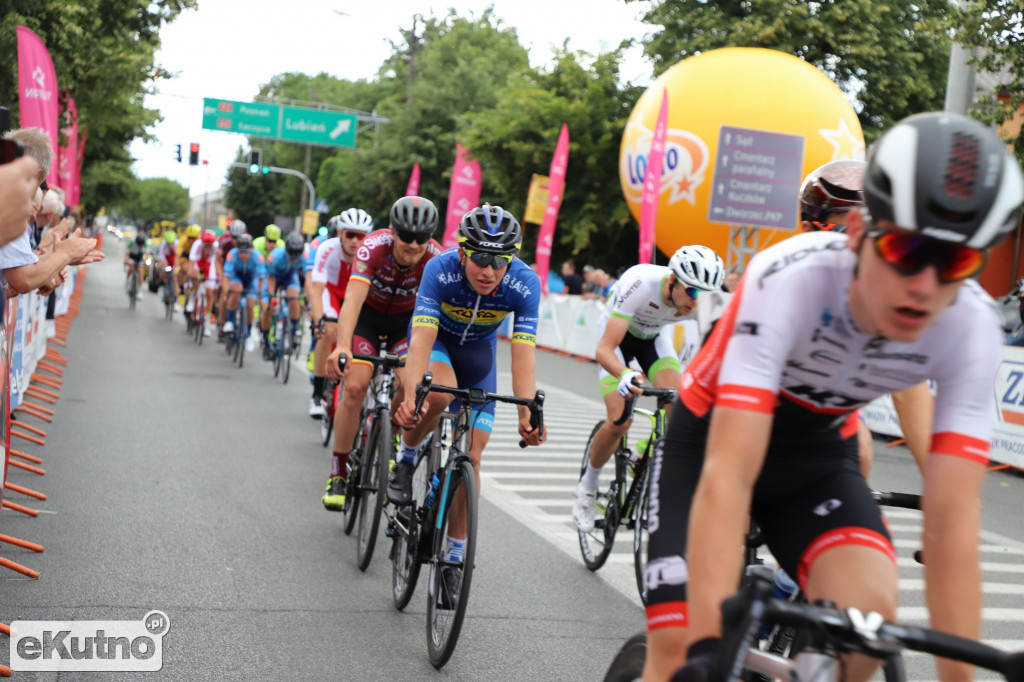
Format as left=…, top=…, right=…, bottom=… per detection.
left=644, top=113, right=1024, bottom=682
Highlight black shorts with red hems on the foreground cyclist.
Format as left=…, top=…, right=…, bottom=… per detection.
left=646, top=400, right=895, bottom=629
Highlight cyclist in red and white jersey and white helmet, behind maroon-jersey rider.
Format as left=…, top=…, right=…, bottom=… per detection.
left=309, top=208, right=374, bottom=419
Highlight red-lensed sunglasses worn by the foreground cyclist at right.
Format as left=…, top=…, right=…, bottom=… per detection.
left=865, top=229, right=985, bottom=284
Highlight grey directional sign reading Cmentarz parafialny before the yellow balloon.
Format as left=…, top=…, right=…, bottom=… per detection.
left=708, top=126, right=804, bottom=229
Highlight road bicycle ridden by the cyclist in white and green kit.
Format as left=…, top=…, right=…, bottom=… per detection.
left=577, top=386, right=677, bottom=604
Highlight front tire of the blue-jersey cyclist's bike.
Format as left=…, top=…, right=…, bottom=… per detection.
left=427, top=461, right=477, bottom=670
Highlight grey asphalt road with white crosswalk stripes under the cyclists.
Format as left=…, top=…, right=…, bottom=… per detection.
left=0, top=241, right=1024, bottom=681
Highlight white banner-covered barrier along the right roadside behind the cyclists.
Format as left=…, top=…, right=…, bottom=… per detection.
left=528, top=293, right=1024, bottom=469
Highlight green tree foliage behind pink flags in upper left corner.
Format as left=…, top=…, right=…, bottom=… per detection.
left=0, top=0, right=197, bottom=213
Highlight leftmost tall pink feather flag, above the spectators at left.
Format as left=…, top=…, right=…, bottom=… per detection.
left=17, top=26, right=59, bottom=185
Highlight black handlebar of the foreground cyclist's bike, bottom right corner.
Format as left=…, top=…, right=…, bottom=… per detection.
left=719, top=579, right=1024, bottom=680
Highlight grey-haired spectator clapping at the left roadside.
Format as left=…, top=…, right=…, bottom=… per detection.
left=0, top=128, right=103, bottom=298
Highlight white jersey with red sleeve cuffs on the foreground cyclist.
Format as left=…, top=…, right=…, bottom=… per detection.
left=679, top=231, right=1002, bottom=463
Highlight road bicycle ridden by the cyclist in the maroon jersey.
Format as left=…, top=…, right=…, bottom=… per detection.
left=335, top=350, right=406, bottom=570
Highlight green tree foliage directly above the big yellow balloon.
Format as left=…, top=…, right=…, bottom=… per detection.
left=625, top=0, right=955, bottom=141
